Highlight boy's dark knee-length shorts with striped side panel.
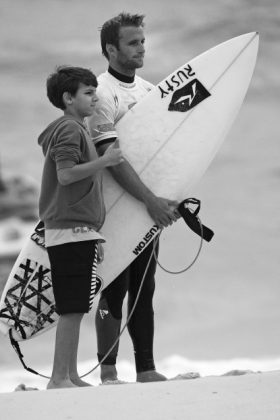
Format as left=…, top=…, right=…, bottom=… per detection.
left=47, top=240, right=98, bottom=315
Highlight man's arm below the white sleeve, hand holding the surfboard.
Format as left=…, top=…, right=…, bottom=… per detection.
left=97, top=139, right=178, bottom=228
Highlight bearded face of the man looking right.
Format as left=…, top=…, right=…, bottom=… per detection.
left=115, top=26, right=145, bottom=70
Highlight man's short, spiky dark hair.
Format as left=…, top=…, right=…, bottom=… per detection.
left=100, top=12, right=145, bottom=59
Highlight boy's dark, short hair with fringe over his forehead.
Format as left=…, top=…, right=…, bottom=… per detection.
left=47, top=66, right=97, bottom=110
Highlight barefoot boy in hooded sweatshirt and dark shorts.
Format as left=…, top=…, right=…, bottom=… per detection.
left=38, top=66, right=122, bottom=389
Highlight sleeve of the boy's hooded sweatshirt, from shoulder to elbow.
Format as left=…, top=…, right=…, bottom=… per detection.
left=50, top=121, right=82, bottom=170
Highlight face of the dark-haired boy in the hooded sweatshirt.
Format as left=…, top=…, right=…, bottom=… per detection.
left=71, top=83, right=98, bottom=118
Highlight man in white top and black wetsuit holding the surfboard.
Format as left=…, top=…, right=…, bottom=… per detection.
left=89, top=13, right=178, bottom=383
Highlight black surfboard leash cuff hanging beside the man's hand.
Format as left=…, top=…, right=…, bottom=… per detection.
left=178, top=198, right=214, bottom=242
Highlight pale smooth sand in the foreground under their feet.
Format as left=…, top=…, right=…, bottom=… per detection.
left=0, top=371, right=280, bottom=420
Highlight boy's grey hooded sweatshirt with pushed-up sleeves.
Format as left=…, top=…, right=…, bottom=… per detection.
left=38, top=116, right=105, bottom=231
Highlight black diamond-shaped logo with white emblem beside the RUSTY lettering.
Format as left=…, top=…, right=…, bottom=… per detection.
left=168, top=79, right=211, bottom=112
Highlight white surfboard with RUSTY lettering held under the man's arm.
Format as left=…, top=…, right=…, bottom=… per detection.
left=0, top=33, right=259, bottom=340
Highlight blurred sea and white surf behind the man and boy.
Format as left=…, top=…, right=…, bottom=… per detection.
left=0, top=0, right=280, bottom=392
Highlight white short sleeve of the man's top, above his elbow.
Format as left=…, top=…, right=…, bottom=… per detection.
left=87, top=91, right=118, bottom=147
